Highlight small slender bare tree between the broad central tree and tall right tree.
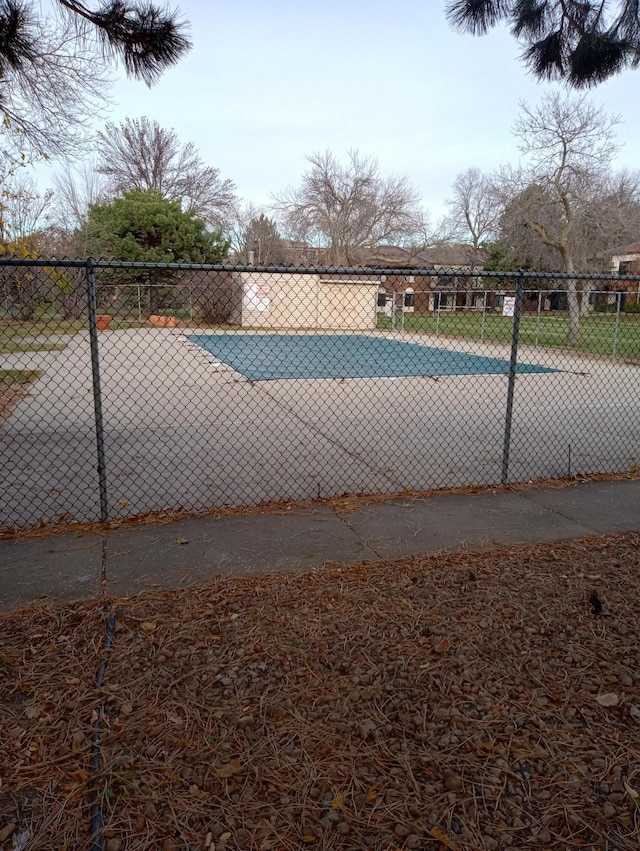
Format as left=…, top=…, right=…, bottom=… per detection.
left=447, top=168, right=500, bottom=307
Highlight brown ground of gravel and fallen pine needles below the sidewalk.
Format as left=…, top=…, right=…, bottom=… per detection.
left=0, top=534, right=640, bottom=851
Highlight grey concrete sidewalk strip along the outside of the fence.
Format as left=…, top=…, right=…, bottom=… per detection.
left=0, top=479, right=640, bottom=611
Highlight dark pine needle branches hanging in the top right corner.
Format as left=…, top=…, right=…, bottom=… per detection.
left=447, top=0, right=640, bottom=88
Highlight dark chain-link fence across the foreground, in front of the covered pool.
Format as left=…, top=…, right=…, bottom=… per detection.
left=0, top=259, right=640, bottom=529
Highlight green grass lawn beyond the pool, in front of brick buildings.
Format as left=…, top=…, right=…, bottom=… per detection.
left=378, top=311, right=640, bottom=358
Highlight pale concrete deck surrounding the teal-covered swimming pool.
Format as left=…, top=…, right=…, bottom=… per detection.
left=0, top=328, right=640, bottom=529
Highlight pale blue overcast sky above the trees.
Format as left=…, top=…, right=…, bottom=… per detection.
left=40, top=0, right=640, bottom=223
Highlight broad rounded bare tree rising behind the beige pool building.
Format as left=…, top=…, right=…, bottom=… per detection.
left=274, top=150, right=424, bottom=265
